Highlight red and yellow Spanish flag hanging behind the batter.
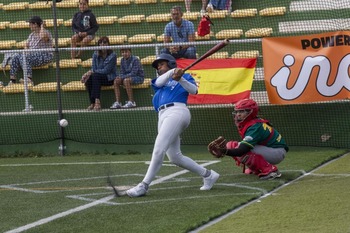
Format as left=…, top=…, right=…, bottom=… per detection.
left=176, top=58, right=256, bottom=104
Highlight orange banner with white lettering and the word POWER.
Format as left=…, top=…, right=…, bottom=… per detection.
left=262, top=31, right=350, bottom=104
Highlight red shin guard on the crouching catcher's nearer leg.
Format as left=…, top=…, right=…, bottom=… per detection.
left=240, top=151, right=278, bottom=177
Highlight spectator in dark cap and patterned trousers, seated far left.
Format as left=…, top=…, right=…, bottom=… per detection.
left=9, top=16, right=53, bottom=85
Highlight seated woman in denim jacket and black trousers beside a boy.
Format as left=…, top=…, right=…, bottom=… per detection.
left=81, top=36, right=117, bottom=111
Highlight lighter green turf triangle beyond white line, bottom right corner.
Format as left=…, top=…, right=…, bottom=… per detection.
left=200, top=152, right=350, bottom=233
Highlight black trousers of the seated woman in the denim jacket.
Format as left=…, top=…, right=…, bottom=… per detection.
left=85, top=74, right=113, bottom=104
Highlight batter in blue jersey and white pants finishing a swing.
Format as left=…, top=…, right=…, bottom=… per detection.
left=126, top=54, right=220, bottom=197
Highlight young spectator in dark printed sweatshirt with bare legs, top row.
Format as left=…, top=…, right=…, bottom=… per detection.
left=71, top=0, right=99, bottom=59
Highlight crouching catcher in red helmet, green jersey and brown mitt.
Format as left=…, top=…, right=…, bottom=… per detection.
left=208, top=99, right=288, bottom=180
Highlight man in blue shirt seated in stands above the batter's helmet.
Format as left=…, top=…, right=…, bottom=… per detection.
left=161, top=6, right=196, bottom=59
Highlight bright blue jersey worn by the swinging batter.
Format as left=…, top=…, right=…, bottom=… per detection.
left=152, top=74, right=196, bottom=111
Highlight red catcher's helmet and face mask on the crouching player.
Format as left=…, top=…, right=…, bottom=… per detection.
left=232, top=99, right=259, bottom=125
